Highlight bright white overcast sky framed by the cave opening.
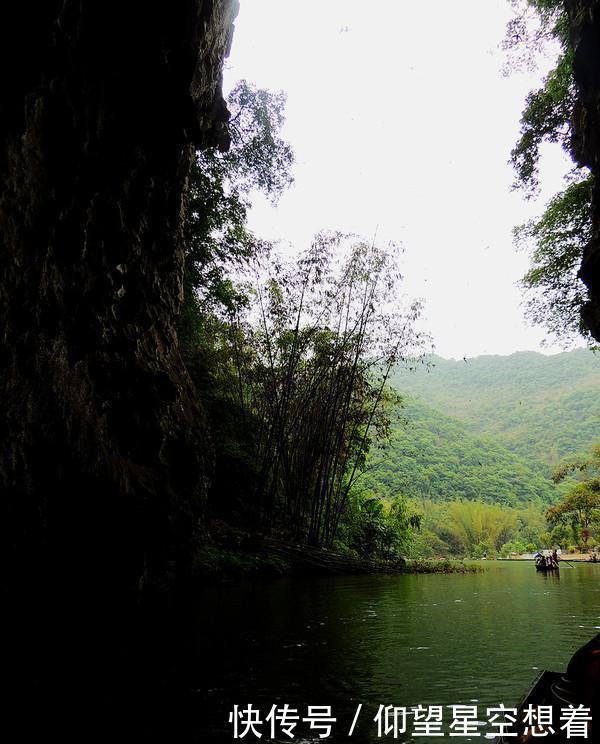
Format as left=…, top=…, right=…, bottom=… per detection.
left=225, top=0, right=570, bottom=358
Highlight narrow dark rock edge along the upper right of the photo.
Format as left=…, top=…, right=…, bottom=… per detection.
left=565, top=0, right=600, bottom=341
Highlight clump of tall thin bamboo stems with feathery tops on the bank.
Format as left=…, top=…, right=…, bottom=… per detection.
left=221, top=234, right=422, bottom=545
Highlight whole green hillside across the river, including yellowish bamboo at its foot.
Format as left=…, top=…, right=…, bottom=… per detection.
left=361, top=350, right=600, bottom=558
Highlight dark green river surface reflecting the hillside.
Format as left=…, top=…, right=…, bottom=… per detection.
left=194, top=562, right=600, bottom=742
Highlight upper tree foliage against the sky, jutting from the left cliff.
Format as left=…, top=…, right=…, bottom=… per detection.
left=178, top=80, right=294, bottom=356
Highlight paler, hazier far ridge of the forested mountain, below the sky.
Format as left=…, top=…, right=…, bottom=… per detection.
left=392, top=349, right=600, bottom=474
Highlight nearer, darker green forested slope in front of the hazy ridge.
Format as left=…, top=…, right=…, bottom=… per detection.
left=361, top=397, right=559, bottom=506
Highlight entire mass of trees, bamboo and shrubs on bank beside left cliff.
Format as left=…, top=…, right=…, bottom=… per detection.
left=179, top=82, right=423, bottom=559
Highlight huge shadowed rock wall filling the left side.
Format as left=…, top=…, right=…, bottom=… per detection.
left=0, top=0, right=236, bottom=708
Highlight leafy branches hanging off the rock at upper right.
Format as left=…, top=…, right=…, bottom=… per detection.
left=505, top=0, right=592, bottom=345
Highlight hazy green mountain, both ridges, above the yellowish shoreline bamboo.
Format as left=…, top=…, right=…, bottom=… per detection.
left=362, top=349, right=600, bottom=506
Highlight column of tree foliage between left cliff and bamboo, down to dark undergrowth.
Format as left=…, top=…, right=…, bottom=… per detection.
left=177, top=81, right=293, bottom=529
